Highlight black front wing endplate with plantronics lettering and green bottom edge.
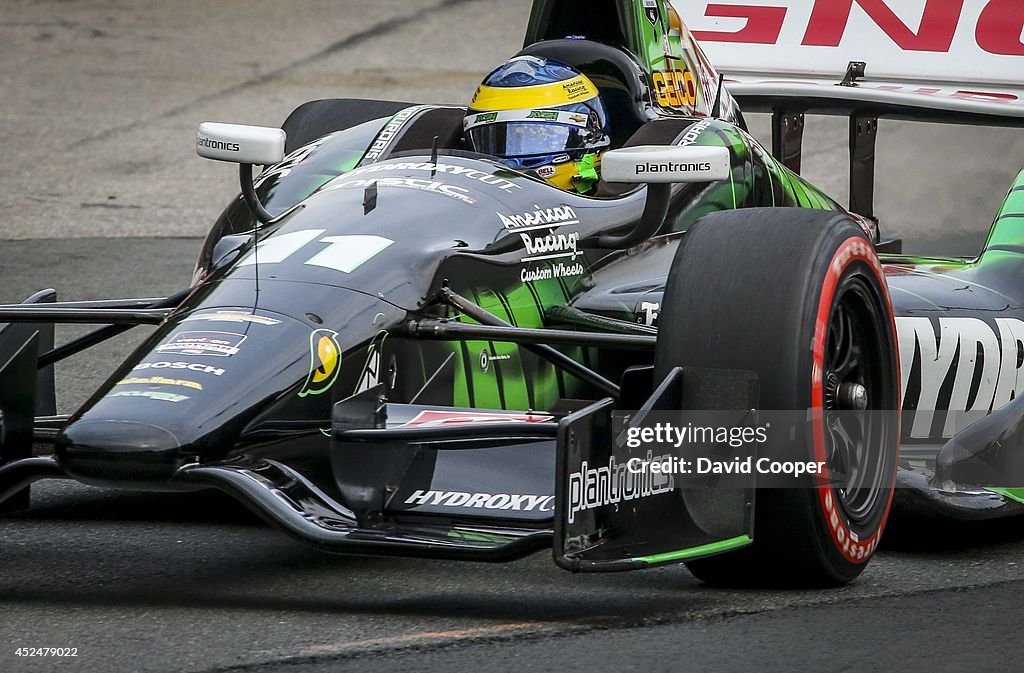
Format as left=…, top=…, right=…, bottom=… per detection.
left=554, top=369, right=758, bottom=572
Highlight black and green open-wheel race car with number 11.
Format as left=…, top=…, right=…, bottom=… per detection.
left=0, top=0, right=1024, bottom=584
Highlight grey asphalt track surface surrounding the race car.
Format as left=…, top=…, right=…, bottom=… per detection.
left=0, top=0, right=1024, bottom=673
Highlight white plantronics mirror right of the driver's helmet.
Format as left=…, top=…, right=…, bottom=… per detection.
left=601, top=145, right=732, bottom=184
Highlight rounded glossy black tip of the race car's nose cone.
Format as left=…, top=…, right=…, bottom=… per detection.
left=56, top=420, right=190, bottom=488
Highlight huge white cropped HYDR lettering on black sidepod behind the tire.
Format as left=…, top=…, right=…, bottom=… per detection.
left=896, top=318, right=1024, bottom=439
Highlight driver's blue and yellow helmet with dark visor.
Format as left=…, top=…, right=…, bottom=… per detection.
left=464, top=56, right=610, bottom=194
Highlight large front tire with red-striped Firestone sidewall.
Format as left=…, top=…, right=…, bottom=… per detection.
left=654, top=208, right=899, bottom=586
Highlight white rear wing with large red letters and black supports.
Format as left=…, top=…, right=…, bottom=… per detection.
left=677, top=0, right=1024, bottom=219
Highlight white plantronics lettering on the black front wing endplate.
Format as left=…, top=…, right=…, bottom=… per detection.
left=568, top=452, right=676, bottom=523
